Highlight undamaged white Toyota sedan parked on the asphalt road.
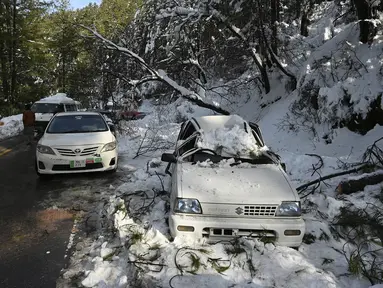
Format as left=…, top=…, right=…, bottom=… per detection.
left=35, top=112, right=118, bottom=176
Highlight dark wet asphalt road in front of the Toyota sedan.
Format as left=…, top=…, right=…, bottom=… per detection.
left=0, top=136, right=115, bottom=288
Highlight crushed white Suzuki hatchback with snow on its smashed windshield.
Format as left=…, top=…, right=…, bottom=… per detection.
left=162, top=115, right=305, bottom=247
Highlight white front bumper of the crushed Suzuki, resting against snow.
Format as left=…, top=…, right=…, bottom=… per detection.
left=169, top=214, right=305, bottom=247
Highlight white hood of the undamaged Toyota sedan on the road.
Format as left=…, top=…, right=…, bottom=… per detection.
left=39, top=131, right=115, bottom=147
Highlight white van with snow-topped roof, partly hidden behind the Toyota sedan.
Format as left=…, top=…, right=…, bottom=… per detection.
left=31, top=94, right=81, bottom=135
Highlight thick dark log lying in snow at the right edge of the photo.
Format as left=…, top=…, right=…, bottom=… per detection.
left=335, top=170, right=383, bottom=195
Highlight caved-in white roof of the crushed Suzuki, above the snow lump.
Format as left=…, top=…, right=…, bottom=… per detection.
left=194, top=115, right=248, bottom=132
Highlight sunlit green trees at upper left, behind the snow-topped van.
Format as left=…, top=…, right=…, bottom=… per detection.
left=0, top=0, right=141, bottom=116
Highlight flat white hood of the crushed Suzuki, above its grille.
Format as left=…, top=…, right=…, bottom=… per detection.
left=177, top=163, right=299, bottom=204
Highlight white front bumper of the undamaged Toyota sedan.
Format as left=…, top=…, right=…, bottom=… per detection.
left=36, top=149, right=118, bottom=174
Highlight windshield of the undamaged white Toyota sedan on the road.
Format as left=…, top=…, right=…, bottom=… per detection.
left=47, top=115, right=108, bottom=134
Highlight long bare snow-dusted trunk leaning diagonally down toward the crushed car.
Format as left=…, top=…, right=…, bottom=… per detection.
left=80, top=25, right=230, bottom=115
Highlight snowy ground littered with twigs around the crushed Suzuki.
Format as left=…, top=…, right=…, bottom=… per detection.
left=59, top=100, right=382, bottom=287
